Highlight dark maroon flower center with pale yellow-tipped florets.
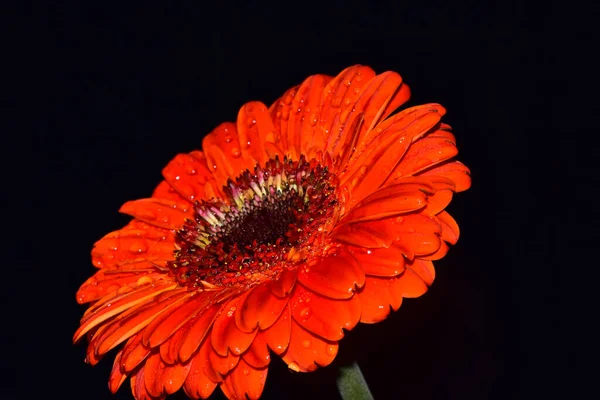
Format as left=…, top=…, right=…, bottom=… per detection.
left=168, top=157, right=338, bottom=289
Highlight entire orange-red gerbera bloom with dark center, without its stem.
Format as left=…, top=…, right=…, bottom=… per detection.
left=74, top=66, right=470, bottom=399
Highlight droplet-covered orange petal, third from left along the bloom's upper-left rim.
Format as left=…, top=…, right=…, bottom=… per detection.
left=202, top=122, right=255, bottom=186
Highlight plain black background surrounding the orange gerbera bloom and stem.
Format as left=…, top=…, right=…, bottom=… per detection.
left=14, top=0, right=592, bottom=400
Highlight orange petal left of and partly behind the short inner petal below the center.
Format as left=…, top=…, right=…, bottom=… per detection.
left=211, top=298, right=256, bottom=357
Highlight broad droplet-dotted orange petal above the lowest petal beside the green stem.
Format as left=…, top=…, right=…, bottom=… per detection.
left=290, top=285, right=360, bottom=341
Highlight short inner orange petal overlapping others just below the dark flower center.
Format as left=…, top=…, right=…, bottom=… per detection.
left=235, top=284, right=287, bottom=332
